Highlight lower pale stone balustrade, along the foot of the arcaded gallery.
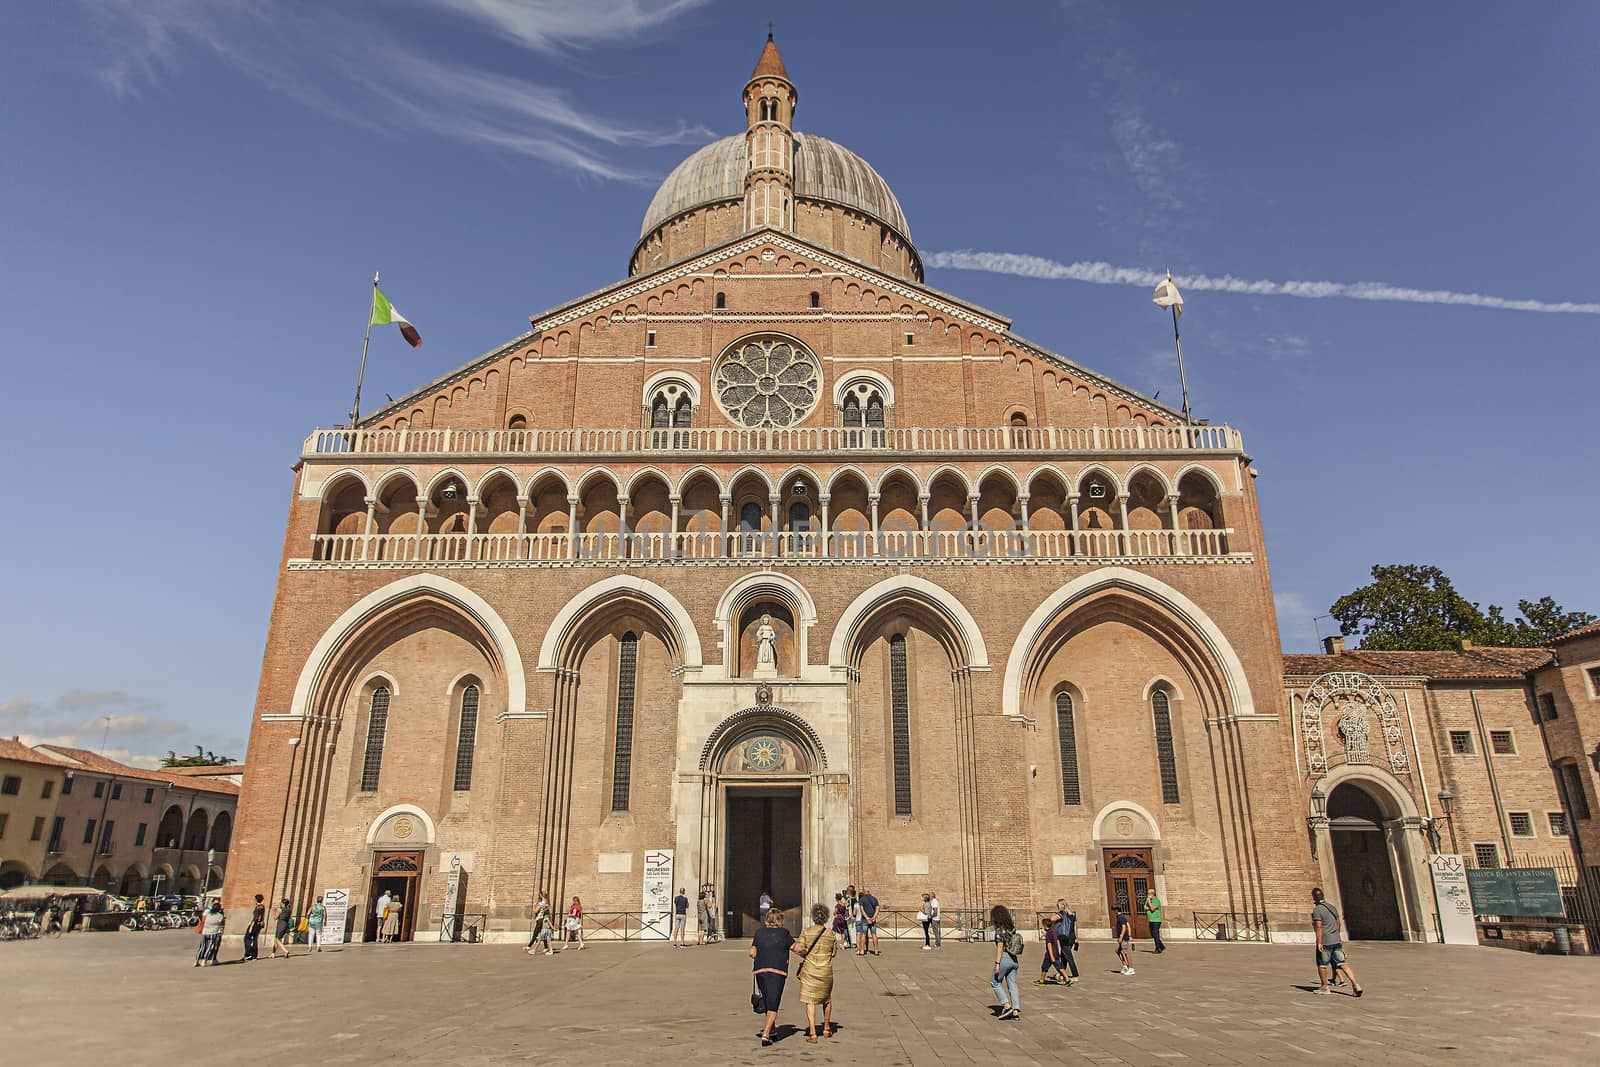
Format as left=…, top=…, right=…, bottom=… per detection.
left=310, top=530, right=1234, bottom=565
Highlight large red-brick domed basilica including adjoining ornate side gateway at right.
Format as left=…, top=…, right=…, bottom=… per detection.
left=227, top=40, right=1587, bottom=937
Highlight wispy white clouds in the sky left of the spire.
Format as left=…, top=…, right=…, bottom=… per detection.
left=68, top=0, right=710, bottom=181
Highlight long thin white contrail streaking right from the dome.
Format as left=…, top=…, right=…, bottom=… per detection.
left=923, top=250, right=1600, bottom=315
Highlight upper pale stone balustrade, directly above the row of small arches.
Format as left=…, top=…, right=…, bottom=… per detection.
left=301, top=426, right=1243, bottom=459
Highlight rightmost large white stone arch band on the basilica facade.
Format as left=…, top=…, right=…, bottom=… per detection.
left=1000, top=566, right=1256, bottom=717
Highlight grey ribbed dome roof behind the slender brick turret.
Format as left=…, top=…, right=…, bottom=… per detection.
left=638, top=131, right=910, bottom=242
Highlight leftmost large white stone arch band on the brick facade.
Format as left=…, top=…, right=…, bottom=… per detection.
left=290, top=574, right=528, bottom=717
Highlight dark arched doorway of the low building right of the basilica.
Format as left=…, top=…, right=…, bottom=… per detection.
left=1328, top=782, right=1405, bottom=941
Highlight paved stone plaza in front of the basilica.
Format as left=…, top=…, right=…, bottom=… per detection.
left=0, top=931, right=1600, bottom=1067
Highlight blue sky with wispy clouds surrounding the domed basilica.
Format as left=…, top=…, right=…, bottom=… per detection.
left=0, top=0, right=1600, bottom=767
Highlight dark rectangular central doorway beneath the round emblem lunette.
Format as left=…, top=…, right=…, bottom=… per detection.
left=722, top=787, right=805, bottom=937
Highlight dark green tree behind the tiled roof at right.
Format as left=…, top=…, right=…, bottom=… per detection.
left=1330, top=563, right=1595, bottom=649
